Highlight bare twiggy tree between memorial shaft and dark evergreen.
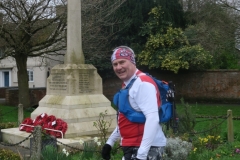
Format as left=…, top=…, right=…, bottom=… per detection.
left=82, top=0, right=130, bottom=70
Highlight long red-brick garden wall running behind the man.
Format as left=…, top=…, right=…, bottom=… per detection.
left=103, top=70, right=240, bottom=103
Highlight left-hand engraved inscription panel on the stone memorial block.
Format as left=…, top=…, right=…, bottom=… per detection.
left=49, top=73, right=67, bottom=91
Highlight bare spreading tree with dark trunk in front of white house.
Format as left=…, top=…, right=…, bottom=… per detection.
left=0, top=0, right=66, bottom=107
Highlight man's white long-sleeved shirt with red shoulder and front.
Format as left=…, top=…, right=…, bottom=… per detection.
left=107, top=70, right=166, bottom=160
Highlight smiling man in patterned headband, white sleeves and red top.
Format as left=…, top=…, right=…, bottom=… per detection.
left=102, top=46, right=166, bottom=160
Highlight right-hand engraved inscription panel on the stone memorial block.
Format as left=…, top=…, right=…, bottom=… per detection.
left=79, top=73, right=92, bottom=93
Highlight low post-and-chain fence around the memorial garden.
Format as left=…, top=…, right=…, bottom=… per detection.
left=0, top=104, right=234, bottom=160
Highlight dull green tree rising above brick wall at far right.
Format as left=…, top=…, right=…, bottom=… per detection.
left=184, top=1, right=240, bottom=69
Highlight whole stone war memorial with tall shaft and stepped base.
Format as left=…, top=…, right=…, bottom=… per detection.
left=2, top=0, right=116, bottom=147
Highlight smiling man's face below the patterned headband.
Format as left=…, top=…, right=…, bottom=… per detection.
left=112, top=59, right=136, bottom=81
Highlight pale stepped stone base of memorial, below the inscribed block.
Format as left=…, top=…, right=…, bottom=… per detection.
left=31, top=95, right=116, bottom=138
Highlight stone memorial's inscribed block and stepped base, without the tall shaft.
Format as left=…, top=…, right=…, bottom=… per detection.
left=31, top=64, right=116, bottom=138
